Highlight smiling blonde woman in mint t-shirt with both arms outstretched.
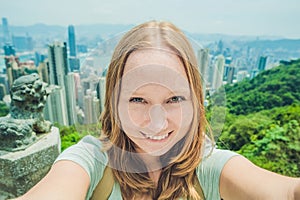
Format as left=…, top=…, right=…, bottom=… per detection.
left=19, top=21, right=300, bottom=200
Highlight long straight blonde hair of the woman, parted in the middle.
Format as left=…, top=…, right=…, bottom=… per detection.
left=101, top=21, right=207, bottom=199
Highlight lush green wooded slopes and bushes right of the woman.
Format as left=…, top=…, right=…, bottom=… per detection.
left=208, top=60, right=300, bottom=177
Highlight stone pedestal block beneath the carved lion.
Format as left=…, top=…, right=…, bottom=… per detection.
left=0, top=127, right=61, bottom=200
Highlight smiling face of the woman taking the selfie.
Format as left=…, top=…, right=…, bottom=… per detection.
left=118, top=49, right=193, bottom=156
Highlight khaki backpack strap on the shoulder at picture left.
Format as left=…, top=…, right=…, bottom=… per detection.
left=91, top=167, right=115, bottom=200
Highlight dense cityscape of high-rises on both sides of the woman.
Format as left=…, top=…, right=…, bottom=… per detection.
left=0, top=17, right=300, bottom=126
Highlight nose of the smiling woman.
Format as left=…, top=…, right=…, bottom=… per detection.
left=148, top=104, right=168, bottom=134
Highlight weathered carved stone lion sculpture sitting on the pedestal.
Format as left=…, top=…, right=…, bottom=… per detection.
left=0, top=74, right=53, bottom=151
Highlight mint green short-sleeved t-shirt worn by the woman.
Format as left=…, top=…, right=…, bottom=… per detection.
left=55, top=135, right=238, bottom=200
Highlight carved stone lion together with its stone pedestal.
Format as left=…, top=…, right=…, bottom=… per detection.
left=0, top=74, right=60, bottom=200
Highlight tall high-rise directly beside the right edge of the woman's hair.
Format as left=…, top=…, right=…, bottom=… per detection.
left=197, top=49, right=209, bottom=97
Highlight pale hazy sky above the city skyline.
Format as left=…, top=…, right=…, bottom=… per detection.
left=0, top=0, right=300, bottom=39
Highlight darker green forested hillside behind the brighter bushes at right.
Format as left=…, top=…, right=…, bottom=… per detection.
left=213, top=60, right=300, bottom=115
